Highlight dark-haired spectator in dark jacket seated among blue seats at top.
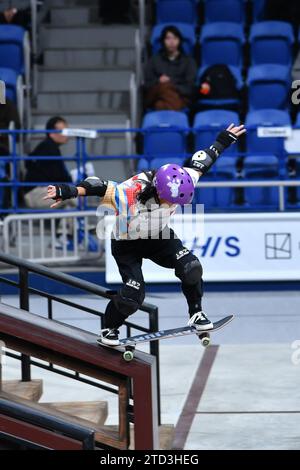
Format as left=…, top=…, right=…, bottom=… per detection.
left=145, top=26, right=197, bottom=111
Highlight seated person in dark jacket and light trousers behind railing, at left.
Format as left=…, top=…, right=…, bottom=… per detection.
left=24, top=116, right=77, bottom=244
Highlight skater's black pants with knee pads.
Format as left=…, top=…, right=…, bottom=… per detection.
left=104, top=230, right=203, bottom=328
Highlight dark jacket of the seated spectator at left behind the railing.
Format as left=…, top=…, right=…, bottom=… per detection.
left=25, top=137, right=72, bottom=191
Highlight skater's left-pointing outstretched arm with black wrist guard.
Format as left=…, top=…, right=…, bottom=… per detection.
left=43, top=176, right=115, bottom=208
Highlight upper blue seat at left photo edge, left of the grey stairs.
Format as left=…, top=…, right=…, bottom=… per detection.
left=0, top=25, right=25, bottom=74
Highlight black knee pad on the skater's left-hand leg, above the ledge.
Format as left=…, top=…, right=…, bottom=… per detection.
left=113, top=279, right=145, bottom=318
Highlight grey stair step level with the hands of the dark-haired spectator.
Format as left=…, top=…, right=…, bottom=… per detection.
left=38, top=70, right=131, bottom=92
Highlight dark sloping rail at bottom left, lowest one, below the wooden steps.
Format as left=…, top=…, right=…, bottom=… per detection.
left=0, top=392, right=95, bottom=450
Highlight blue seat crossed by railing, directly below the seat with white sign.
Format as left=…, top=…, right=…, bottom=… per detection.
left=244, top=156, right=279, bottom=210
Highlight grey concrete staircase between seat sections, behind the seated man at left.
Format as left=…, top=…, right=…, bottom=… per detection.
left=33, top=0, right=137, bottom=179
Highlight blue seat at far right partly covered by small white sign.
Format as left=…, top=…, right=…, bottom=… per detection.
left=245, top=109, right=292, bottom=158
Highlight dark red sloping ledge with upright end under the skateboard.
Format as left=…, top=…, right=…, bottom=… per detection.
left=0, top=303, right=158, bottom=449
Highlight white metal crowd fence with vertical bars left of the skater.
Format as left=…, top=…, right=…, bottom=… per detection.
left=3, top=211, right=102, bottom=263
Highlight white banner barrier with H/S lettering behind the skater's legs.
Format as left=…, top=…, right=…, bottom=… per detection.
left=105, top=213, right=300, bottom=283
